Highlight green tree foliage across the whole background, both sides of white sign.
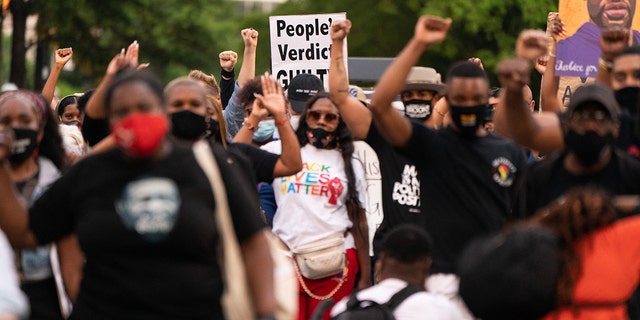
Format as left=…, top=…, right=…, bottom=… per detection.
left=5, top=0, right=557, bottom=92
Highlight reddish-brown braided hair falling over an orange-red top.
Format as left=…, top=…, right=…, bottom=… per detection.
left=530, top=187, right=617, bottom=306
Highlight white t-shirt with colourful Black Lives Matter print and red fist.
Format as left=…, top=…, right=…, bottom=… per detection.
left=262, top=141, right=366, bottom=248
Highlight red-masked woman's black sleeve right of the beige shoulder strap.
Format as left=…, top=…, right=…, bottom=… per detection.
left=212, top=141, right=266, bottom=242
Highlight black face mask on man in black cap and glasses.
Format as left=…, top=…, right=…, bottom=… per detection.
left=564, top=129, right=615, bottom=166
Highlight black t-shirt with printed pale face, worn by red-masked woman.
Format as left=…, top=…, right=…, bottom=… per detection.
left=30, top=144, right=264, bottom=319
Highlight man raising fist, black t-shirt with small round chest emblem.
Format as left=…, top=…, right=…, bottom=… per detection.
left=370, top=16, right=526, bottom=318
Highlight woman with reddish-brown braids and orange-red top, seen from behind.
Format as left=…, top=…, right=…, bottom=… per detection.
left=529, top=187, right=640, bottom=320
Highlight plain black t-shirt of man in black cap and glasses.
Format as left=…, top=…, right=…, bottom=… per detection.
left=526, top=150, right=640, bottom=215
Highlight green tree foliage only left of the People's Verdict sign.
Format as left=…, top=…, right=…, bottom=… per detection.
left=29, top=0, right=235, bottom=84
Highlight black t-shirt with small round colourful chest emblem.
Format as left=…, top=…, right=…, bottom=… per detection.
left=403, top=123, right=527, bottom=273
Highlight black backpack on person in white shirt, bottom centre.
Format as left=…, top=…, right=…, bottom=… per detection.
left=331, top=284, right=420, bottom=320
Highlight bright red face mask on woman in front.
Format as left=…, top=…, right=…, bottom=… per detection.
left=111, top=113, right=168, bottom=158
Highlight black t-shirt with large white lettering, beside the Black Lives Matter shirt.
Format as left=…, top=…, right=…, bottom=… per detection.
left=364, top=122, right=425, bottom=255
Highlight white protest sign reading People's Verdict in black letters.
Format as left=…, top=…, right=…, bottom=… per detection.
left=269, top=12, right=348, bottom=89
